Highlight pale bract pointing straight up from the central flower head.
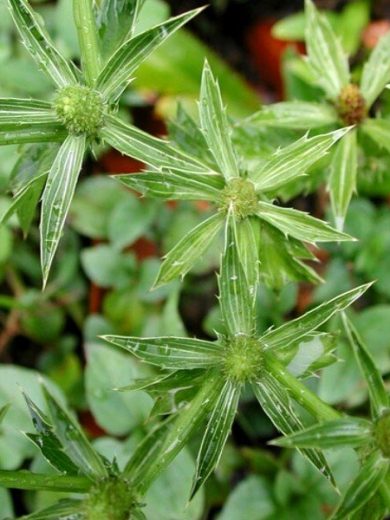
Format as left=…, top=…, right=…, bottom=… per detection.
left=199, top=61, right=239, bottom=180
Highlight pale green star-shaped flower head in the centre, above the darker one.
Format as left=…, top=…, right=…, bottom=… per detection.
left=115, top=62, right=351, bottom=291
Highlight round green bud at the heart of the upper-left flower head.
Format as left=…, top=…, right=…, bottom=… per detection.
left=54, top=85, right=104, bottom=136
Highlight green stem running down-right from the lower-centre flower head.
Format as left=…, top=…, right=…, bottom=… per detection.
left=267, top=356, right=340, bottom=421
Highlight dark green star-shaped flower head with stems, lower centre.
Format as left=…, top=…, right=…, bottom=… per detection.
left=104, top=212, right=368, bottom=493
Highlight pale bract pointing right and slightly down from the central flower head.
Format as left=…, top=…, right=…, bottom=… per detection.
left=257, top=202, right=354, bottom=243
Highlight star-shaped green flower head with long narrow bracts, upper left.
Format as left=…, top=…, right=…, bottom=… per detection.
left=0, top=0, right=200, bottom=285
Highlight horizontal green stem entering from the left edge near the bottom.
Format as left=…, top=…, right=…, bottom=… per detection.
left=0, top=470, right=93, bottom=493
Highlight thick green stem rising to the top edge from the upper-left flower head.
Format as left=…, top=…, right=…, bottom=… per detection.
left=73, top=0, right=101, bottom=86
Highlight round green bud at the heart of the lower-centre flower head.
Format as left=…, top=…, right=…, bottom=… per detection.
left=223, top=334, right=263, bottom=383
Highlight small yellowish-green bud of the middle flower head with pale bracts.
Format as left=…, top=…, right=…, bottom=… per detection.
left=219, top=178, right=258, bottom=219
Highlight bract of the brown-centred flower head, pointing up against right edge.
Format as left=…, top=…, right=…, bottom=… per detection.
left=360, top=34, right=390, bottom=107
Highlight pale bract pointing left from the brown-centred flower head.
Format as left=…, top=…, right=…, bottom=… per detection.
left=248, top=101, right=338, bottom=130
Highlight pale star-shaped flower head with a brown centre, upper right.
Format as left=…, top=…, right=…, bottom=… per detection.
left=247, top=0, right=390, bottom=229
